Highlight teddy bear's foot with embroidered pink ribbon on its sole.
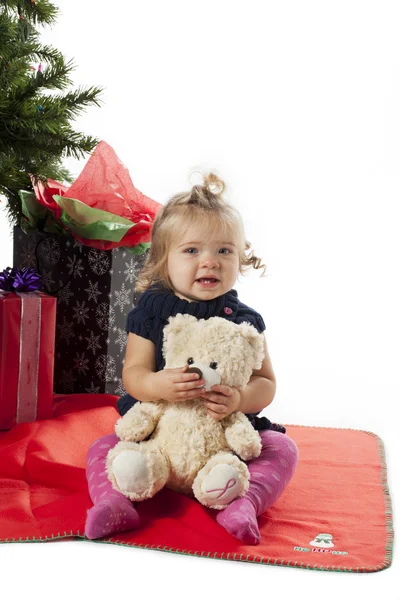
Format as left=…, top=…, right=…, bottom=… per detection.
left=193, top=453, right=249, bottom=510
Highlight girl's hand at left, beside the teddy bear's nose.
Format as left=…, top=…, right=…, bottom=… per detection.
left=153, top=364, right=205, bottom=402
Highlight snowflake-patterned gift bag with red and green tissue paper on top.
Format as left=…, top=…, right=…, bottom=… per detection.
left=14, top=141, right=161, bottom=395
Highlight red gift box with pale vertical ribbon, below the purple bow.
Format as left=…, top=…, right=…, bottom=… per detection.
left=0, top=292, right=57, bottom=429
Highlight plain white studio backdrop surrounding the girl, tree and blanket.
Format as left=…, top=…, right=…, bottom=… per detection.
left=0, top=0, right=400, bottom=600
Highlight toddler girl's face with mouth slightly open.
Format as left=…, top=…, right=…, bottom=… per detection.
left=167, top=226, right=239, bottom=302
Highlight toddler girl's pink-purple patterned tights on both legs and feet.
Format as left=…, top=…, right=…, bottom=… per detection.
left=85, top=430, right=298, bottom=544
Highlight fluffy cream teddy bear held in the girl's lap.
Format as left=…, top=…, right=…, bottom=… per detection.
left=106, top=314, right=264, bottom=510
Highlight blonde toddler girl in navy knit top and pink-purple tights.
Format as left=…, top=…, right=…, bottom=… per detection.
left=85, top=173, right=298, bottom=544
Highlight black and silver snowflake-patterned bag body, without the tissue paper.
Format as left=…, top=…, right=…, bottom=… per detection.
left=14, top=227, right=148, bottom=395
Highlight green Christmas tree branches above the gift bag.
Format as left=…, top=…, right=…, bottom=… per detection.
left=0, top=0, right=102, bottom=223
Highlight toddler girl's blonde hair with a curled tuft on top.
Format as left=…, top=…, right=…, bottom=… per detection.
left=135, top=173, right=266, bottom=292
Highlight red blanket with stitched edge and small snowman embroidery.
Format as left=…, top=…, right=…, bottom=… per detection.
left=0, top=394, right=393, bottom=572
